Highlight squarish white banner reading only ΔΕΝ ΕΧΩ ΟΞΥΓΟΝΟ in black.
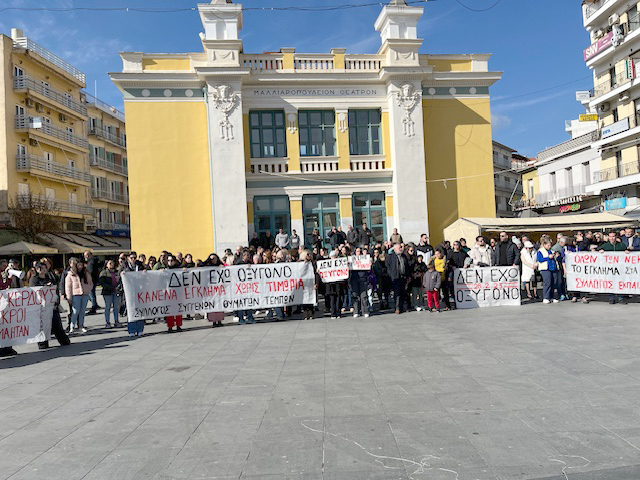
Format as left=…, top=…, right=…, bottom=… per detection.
left=453, top=267, right=520, bottom=308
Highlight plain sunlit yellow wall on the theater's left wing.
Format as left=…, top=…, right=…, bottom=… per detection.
left=126, top=102, right=213, bottom=258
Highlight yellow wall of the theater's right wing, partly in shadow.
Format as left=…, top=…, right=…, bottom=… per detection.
left=423, top=98, right=496, bottom=243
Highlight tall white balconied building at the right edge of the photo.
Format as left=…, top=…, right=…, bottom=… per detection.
left=583, top=0, right=640, bottom=216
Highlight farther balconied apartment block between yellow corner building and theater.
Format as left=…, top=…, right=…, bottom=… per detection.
left=83, top=92, right=129, bottom=236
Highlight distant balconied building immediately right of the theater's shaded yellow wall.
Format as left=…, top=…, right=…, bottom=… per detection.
left=493, top=140, right=528, bottom=218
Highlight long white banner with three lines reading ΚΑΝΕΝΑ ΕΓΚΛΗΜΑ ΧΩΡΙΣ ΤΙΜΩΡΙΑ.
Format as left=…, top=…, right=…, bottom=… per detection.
left=122, top=262, right=316, bottom=320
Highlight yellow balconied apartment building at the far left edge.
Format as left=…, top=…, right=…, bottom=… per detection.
left=0, top=29, right=93, bottom=231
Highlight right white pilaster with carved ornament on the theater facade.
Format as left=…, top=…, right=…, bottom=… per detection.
left=387, top=80, right=429, bottom=243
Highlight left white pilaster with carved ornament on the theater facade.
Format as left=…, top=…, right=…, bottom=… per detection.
left=207, top=80, right=249, bottom=253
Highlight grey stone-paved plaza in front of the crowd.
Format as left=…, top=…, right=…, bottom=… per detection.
left=0, top=302, right=640, bottom=480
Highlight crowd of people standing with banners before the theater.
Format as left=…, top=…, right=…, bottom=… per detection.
left=0, top=224, right=640, bottom=356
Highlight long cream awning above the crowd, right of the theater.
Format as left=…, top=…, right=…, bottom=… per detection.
left=444, top=213, right=640, bottom=244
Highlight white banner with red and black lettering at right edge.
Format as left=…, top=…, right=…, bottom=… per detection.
left=565, top=252, right=640, bottom=295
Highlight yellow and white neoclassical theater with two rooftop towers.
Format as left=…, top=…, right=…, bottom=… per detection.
left=111, top=0, right=501, bottom=258
